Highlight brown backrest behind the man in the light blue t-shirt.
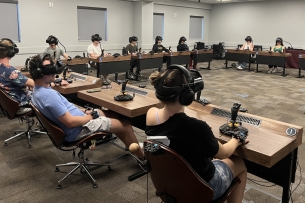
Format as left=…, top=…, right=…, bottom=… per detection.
left=30, top=102, right=65, bottom=148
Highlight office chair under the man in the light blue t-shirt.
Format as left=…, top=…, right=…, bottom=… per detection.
left=30, top=103, right=129, bottom=189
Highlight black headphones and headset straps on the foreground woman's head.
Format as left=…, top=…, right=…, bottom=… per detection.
left=155, top=65, right=195, bottom=106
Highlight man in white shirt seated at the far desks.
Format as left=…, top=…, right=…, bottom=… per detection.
left=87, top=34, right=111, bottom=85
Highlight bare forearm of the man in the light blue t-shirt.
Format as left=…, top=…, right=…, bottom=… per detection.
left=58, top=111, right=92, bottom=128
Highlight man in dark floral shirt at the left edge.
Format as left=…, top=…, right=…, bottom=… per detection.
left=0, top=38, right=34, bottom=114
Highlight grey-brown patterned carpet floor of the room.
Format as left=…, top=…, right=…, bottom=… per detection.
left=0, top=60, right=305, bottom=203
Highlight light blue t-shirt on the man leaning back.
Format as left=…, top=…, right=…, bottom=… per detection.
left=32, top=86, right=85, bottom=142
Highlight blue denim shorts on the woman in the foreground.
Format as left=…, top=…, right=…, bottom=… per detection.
left=208, top=160, right=233, bottom=199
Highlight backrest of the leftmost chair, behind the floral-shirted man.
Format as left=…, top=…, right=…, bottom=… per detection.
left=0, top=88, right=20, bottom=119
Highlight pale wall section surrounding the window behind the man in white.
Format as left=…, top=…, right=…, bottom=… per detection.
left=11, top=0, right=133, bottom=65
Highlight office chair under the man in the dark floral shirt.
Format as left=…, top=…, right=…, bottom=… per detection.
left=0, top=88, right=46, bottom=148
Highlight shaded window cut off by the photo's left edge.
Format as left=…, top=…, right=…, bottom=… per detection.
left=0, top=1, right=20, bottom=42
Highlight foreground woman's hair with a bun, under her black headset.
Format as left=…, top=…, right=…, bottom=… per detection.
left=149, top=69, right=187, bottom=104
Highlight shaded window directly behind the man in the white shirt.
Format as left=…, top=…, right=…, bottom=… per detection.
left=77, top=6, right=107, bottom=41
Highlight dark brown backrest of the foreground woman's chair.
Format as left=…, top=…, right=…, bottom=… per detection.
left=144, top=140, right=213, bottom=203
